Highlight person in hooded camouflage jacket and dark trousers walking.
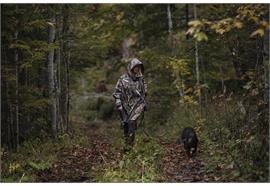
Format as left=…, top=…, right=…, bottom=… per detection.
left=113, top=58, right=147, bottom=149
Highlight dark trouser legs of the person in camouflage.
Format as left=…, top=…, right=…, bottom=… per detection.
left=124, top=120, right=137, bottom=147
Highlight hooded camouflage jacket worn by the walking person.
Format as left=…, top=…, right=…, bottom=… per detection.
left=113, top=59, right=147, bottom=120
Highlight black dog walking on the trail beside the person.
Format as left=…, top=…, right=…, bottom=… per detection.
left=181, top=127, right=199, bottom=157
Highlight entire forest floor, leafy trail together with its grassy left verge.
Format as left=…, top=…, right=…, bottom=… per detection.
left=1, top=95, right=258, bottom=183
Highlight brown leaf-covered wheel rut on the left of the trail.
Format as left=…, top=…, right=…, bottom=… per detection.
left=34, top=125, right=120, bottom=182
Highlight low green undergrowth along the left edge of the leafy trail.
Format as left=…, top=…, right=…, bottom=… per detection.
left=1, top=131, right=87, bottom=182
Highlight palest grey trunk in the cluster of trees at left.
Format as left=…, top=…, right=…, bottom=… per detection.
left=48, top=10, right=56, bottom=137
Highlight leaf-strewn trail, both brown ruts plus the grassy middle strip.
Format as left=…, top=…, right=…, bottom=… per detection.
left=32, top=118, right=222, bottom=182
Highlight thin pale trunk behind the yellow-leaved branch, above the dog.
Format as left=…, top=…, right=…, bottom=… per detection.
left=194, top=4, right=201, bottom=105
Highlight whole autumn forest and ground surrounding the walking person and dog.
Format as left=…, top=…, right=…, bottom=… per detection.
left=1, top=4, right=270, bottom=182
